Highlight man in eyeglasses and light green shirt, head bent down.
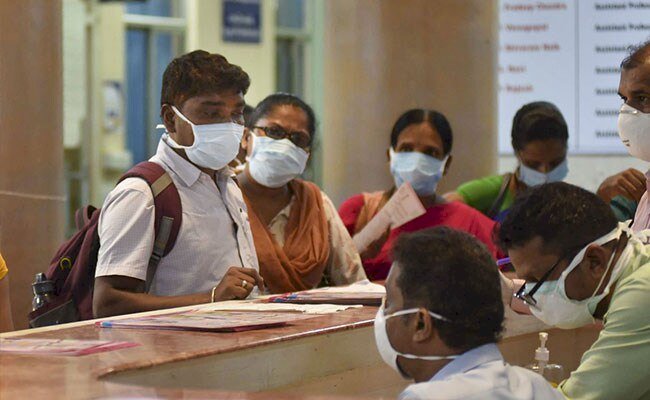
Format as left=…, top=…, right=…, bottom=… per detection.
left=498, top=183, right=650, bottom=399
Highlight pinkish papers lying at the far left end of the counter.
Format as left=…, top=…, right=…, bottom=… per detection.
left=0, top=338, right=138, bottom=356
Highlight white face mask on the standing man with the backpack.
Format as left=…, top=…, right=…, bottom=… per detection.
left=159, top=106, right=244, bottom=170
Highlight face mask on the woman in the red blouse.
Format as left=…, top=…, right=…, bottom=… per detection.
left=388, top=147, right=448, bottom=196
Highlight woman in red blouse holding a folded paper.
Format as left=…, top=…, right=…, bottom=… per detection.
left=339, top=109, right=497, bottom=280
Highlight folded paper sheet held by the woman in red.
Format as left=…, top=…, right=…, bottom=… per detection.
left=352, top=182, right=426, bottom=252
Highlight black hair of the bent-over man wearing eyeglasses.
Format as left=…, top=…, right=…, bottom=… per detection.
left=498, top=182, right=618, bottom=256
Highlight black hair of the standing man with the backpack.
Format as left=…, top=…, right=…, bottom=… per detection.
left=160, top=50, right=251, bottom=107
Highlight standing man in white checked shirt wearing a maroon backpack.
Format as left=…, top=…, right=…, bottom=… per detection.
left=93, top=50, right=264, bottom=317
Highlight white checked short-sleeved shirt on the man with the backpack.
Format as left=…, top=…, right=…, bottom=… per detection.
left=95, top=140, right=259, bottom=296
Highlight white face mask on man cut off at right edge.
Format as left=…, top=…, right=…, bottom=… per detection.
left=618, top=104, right=650, bottom=162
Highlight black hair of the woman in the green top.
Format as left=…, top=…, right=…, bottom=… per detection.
left=512, top=101, right=569, bottom=151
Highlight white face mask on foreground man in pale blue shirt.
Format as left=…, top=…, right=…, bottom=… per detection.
left=374, top=305, right=458, bottom=379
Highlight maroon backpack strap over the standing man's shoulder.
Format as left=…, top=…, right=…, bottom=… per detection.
left=120, top=161, right=183, bottom=292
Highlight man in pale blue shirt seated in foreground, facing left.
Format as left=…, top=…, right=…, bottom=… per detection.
left=375, top=227, right=563, bottom=400
